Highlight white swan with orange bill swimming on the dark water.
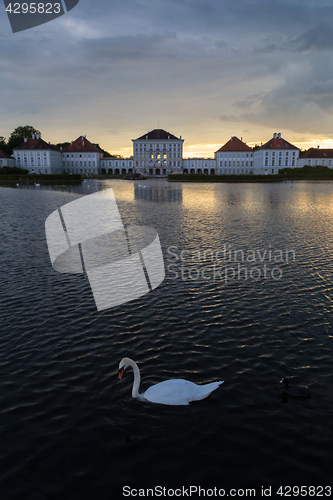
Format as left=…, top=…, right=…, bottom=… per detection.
left=118, top=358, right=224, bottom=405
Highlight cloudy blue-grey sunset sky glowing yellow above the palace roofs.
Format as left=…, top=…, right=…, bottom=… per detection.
left=0, top=0, right=333, bottom=156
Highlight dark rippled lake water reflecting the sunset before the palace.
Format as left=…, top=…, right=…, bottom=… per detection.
left=0, top=179, right=333, bottom=500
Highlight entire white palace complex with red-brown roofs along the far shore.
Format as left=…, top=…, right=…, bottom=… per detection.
left=9, top=129, right=333, bottom=176
